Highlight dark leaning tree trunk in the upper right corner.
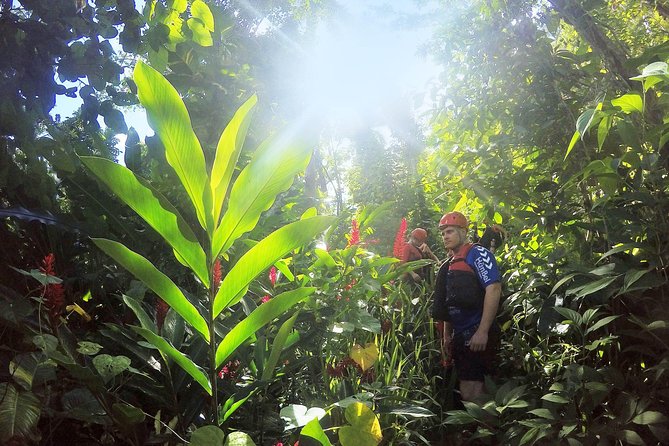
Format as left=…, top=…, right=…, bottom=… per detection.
left=548, top=0, right=635, bottom=90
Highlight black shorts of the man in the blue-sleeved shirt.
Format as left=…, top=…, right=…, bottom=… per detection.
left=452, top=324, right=500, bottom=381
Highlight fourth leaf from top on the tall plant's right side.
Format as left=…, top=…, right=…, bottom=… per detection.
left=216, top=287, right=316, bottom=368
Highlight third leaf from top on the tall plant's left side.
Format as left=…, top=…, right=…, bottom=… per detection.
left=91, top=238, right=209, bottom=342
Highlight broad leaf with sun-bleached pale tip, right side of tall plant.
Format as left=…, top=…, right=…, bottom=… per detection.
left=211, top=136, right=311, bottom=258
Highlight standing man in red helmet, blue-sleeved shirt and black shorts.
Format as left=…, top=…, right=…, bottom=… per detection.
left=432, top=212, right=502, bottom=401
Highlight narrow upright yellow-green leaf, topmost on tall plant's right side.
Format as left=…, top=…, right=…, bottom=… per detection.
left=211, top=95, right=258, bottom=223
